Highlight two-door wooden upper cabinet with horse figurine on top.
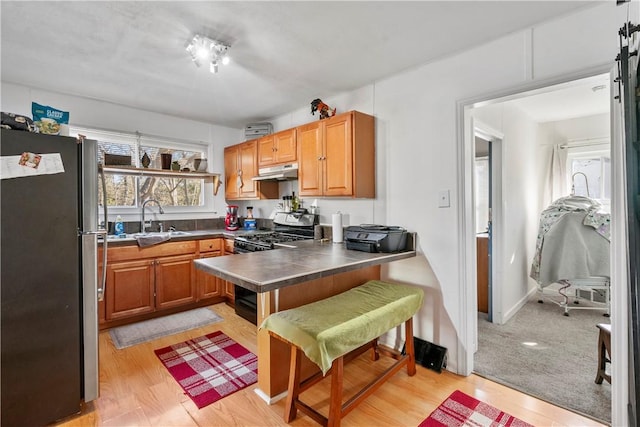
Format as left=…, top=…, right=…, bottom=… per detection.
left=297, top=111, right=375, bottom=198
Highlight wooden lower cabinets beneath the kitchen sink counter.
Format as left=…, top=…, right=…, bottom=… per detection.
left=98, top=238, right=233, bottom=328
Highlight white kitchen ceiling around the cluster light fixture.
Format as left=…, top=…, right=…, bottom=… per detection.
left=0, top=0, right=597, bottom=128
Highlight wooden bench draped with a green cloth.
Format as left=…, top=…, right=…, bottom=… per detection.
left=261, top=280, right=424, bottom=426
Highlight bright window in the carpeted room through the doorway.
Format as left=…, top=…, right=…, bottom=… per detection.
left=567, top=146, right=611, bottom=209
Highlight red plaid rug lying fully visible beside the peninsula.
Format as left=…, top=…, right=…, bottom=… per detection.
left=154, top=331, right=258, bottom=408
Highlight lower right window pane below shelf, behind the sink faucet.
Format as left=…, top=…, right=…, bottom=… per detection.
left=138, top=177, right=204, bottom=206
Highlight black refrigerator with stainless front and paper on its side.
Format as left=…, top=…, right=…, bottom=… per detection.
left=0, top=129, right=104, bottom=427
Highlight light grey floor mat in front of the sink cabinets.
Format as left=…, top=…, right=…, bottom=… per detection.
left=109, top=308, right=223, bottom=349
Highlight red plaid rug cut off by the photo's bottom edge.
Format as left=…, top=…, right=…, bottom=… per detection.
left=419, top=390, right=533, bottom=427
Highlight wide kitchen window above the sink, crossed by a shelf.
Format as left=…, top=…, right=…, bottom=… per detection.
left=70, top=128, right=208, bottom=213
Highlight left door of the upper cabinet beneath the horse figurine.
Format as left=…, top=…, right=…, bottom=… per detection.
left=297, top=121, right=324, bottom=196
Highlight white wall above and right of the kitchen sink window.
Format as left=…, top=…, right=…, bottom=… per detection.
left=0, top=82, right=243, bottom=221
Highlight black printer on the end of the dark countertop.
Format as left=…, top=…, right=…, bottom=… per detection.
left=344, top=224, right=407, bottom=252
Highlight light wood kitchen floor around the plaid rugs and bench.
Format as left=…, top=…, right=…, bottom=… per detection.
left=57, top=304, right=602, bottom=427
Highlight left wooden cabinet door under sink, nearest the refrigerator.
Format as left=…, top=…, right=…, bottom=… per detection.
left=104, top=260, right=154, bottom=320
